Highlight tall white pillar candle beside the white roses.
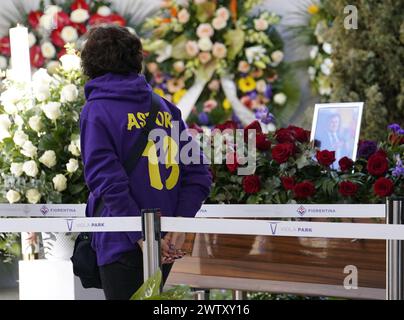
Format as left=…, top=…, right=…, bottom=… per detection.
left=10, top=25, right=31, bottom=82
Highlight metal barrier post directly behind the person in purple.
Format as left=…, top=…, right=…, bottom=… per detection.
left=142, top=209, right=162, bottom=291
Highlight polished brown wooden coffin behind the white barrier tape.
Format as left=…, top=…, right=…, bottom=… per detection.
left=168, top=219, right=386, bottom=299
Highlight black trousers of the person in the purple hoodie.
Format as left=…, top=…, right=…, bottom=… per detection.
left=100, top=246, right=172, bottom=300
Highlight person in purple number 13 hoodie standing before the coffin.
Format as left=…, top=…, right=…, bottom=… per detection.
left=80, top=25, right=212, bottom=299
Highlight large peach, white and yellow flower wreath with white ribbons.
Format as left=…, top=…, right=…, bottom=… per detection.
left=143, top=0, right=289, bottom=125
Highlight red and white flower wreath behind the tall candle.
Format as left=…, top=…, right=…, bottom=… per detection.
left=0, top=0, right=126, bottom=68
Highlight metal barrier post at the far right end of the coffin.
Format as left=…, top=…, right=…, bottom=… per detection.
left=386, top=197, right=404, bottom=300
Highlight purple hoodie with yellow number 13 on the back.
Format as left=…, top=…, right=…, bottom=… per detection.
left=80, top=73, right=212, bottom=266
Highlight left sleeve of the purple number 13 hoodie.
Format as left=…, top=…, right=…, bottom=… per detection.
left=80, top=120, right=141, bottom=243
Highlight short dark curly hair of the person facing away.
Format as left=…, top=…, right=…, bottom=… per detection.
left=81, top=25, right=143, bottom=79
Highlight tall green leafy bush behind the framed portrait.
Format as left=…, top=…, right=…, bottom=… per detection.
left=328, top=0, right=404, bottom=139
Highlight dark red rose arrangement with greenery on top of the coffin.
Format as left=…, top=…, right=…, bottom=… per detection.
left=208, top=122, right=404, bottom=203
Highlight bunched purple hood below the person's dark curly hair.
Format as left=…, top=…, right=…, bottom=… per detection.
left=84, top=73, right=152, bottom=103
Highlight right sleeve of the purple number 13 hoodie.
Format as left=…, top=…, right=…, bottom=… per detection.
left=174, top=120, right=212, bottom=217
